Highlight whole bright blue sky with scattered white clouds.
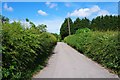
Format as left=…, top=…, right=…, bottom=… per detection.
left=0, top=2, right=118, bottom=33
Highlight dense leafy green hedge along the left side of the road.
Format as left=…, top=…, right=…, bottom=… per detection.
left=2, top=22, right=57, bottom=80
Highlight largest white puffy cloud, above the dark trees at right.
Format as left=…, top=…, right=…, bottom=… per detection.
left=69, top=5, right=110, bottom=17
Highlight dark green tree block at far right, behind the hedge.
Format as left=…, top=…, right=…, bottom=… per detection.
left=91, top=15, right=120, bottom=31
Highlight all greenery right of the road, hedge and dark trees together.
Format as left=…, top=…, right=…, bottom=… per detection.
left=60, top=16, right=120, bottom=76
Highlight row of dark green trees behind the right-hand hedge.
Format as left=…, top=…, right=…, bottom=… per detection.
left=60, top=15, right=120, bottom=39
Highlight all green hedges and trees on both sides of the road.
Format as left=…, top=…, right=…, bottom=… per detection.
left=0, top=15, right=120, bottom=80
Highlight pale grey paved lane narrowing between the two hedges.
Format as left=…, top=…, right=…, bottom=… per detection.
left=33, top=42, right=117, bottom=78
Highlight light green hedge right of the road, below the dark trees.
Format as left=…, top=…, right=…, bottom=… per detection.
left=64, top=28, right=120, bottom=75
